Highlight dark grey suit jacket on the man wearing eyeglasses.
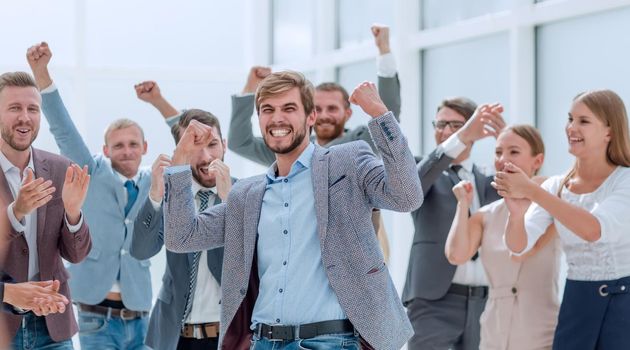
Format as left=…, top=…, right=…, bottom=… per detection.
left=402, top=147, right=500, bottom=305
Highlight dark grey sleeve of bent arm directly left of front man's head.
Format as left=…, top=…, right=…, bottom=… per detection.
left=228, top=94, right=276, bottom=166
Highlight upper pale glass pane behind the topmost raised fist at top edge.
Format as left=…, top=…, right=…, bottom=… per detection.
left=337, top=0, right=394, bottom=47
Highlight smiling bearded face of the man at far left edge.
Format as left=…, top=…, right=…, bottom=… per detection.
left=0, top=86, right=41, bottom=151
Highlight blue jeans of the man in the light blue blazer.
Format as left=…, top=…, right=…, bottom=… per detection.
left=79, top=310, right=148, bottom=350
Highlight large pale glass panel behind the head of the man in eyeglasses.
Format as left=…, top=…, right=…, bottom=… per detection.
left=422, top=34, right=509, bottom=171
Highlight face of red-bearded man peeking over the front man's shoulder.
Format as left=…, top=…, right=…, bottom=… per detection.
left=315, top=90, right=352, bottom=143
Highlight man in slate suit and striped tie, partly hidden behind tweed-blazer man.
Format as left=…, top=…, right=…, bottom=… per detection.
left=130, top=109, right=232, bottom=350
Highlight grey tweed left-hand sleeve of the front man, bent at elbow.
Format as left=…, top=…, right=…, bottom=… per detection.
left=163, top=166, right=228, bottom=253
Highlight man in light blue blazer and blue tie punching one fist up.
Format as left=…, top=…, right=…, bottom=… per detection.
left=27, top=43, right=152, bottom=349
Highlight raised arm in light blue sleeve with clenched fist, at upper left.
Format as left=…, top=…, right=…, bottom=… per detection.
left=26, top=42, right=96, bottom=173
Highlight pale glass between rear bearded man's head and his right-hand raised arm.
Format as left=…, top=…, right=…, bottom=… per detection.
left=337, top=60, right=377, bottom=129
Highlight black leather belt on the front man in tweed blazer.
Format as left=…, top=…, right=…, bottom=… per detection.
left=254, top=320, right=355, bottom=341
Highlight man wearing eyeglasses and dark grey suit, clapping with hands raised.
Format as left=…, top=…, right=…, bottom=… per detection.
left=402, top=97, right=505, bottom=350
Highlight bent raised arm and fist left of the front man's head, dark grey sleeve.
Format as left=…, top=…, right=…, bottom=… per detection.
left=228, top=66, right=276, bottom=166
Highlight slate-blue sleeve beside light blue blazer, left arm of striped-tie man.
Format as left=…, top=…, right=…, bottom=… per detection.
left=129, top=197, right=164, bottom=260
